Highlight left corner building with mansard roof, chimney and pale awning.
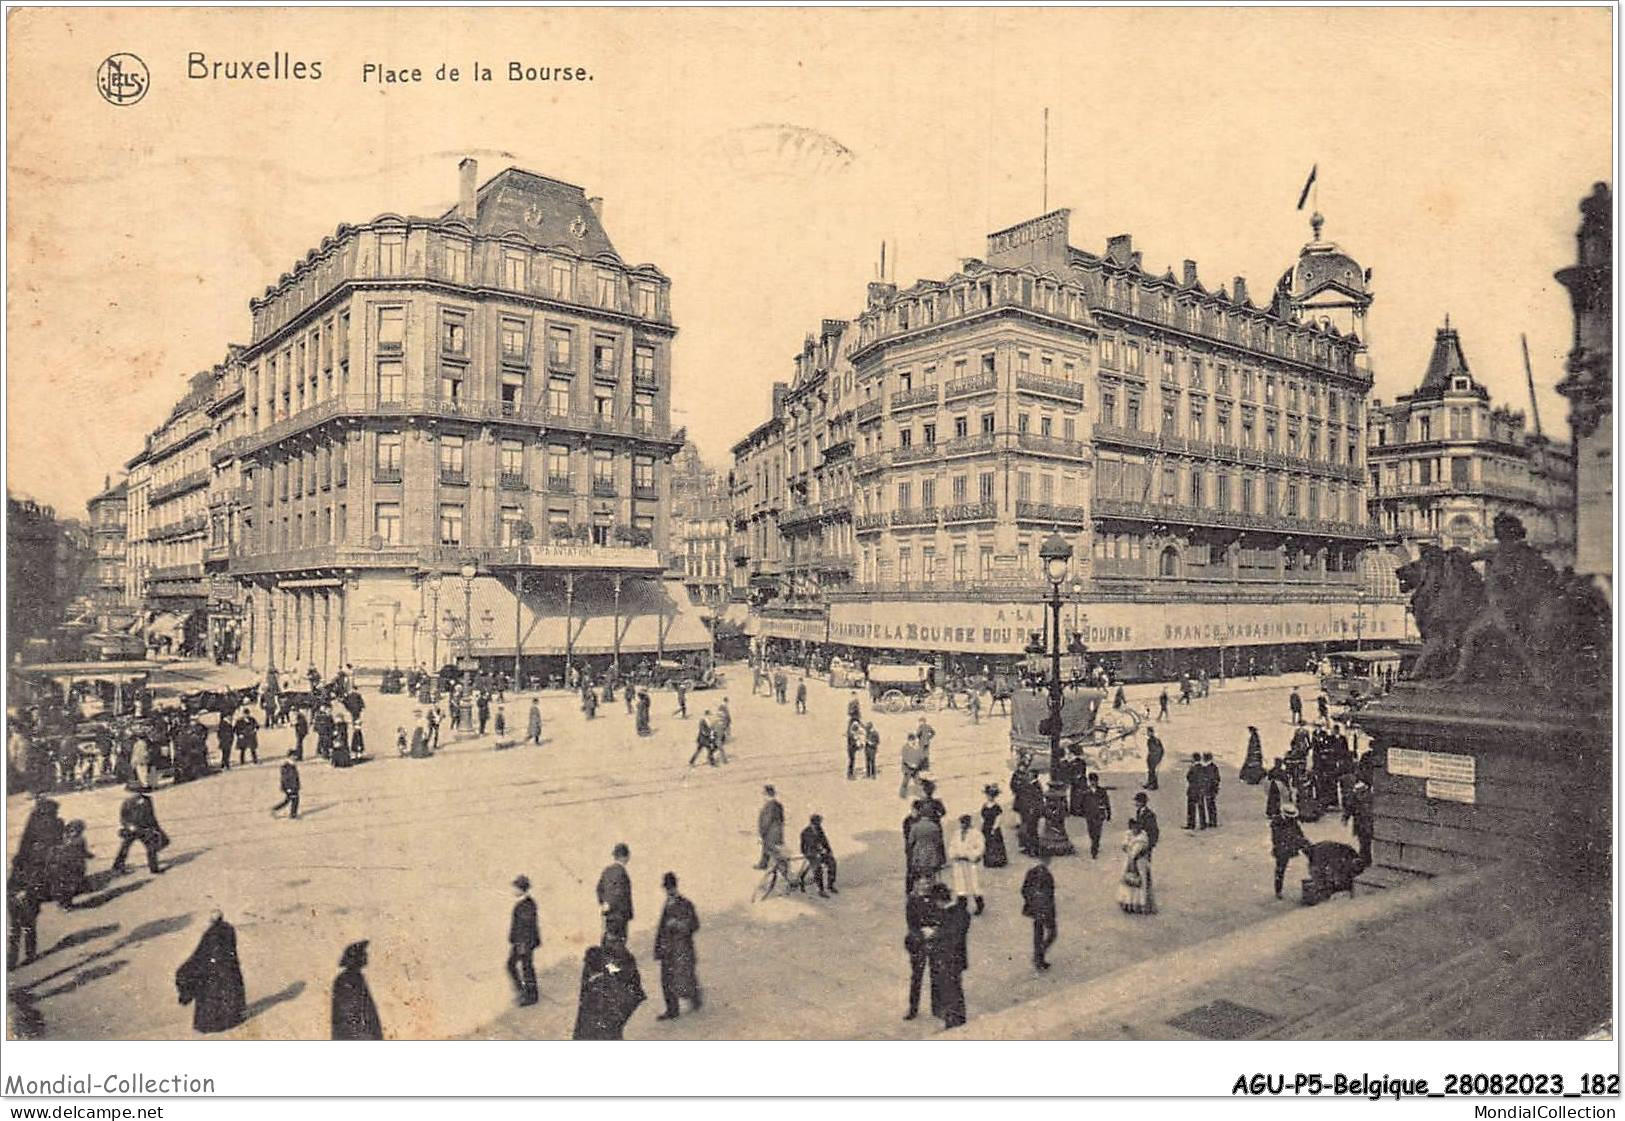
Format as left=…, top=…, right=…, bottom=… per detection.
left=216, top=159, right=707, bottom=676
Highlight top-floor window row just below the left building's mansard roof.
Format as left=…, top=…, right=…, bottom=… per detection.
left=254, top=231, right=670, bottom=341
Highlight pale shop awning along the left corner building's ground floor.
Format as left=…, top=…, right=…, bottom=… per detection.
left=458, top=573, right=710, bottom=658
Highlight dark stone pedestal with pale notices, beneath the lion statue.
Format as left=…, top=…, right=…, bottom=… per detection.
left=1354, top=682, right=1614, bottom=877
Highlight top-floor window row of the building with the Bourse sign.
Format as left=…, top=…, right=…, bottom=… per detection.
left=858, top=273, right=1354, bottom=372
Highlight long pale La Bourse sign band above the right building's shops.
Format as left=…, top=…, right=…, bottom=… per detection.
left=829, top=596, right=1406, bottom=655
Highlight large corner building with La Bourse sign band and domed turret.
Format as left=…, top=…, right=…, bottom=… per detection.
left=736, top=210, right=1404, bottom=677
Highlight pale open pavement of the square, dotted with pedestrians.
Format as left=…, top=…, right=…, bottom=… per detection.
left=8, top=666, right=1346, bottom=1038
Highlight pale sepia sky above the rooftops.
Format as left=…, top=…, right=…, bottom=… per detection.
left=7, top=8, right=1614, bottom=515
